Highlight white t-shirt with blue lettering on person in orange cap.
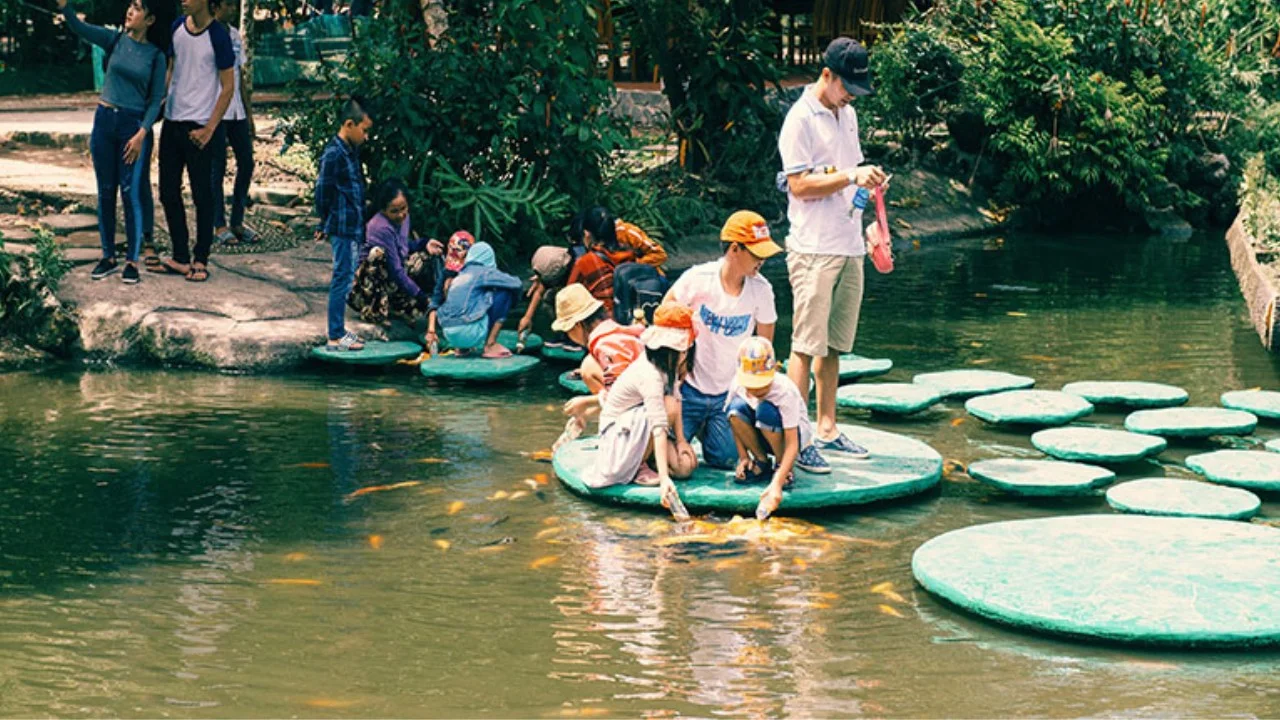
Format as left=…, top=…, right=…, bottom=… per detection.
left=671, top=258, right=778, bottom=395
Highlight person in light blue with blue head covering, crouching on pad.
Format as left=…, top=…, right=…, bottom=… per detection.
left=439, top=242, right=521, bottom=359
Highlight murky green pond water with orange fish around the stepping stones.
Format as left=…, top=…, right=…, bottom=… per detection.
left=0, top=229, right=1280, bottom=717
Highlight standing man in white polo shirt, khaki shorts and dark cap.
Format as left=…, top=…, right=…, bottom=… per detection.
left=778, top=37, right=886, bottom=457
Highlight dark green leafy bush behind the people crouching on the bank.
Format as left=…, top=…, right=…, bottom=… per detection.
left=287, top=0, right=622, bottom=259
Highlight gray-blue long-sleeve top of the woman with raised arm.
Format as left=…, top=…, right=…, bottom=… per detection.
left=63, top=3, right=168, bottom=131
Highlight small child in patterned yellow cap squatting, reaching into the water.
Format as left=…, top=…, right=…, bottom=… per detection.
left=726, top=336, right=831, bottom=519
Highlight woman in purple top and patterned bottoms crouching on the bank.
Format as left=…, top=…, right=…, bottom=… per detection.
left=347, top=179, right=444, bottom=346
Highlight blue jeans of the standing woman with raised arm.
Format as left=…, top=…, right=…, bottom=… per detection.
left=88, top=105, right=151, bottom=263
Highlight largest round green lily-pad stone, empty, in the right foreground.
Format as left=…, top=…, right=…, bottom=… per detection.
left=911, top=515, right=1280, bottom=647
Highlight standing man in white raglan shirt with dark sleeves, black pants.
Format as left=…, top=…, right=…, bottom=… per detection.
left=147, top=0, right=236, bottom=282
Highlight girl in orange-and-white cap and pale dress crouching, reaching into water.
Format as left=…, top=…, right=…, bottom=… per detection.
left=589, top=302, right=698, bottom=510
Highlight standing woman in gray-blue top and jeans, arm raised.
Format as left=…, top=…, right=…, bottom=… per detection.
left=58, top=0, right=168, bottom=283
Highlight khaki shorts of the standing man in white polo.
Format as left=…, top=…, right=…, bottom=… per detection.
left=787, top=252, right=865, bottom=357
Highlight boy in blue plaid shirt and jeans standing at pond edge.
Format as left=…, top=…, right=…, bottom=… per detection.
left=315, top=100, right=374, bottom=351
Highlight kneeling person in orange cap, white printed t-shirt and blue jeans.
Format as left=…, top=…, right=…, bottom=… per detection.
left=667, top=210, right=782, bottom=469
